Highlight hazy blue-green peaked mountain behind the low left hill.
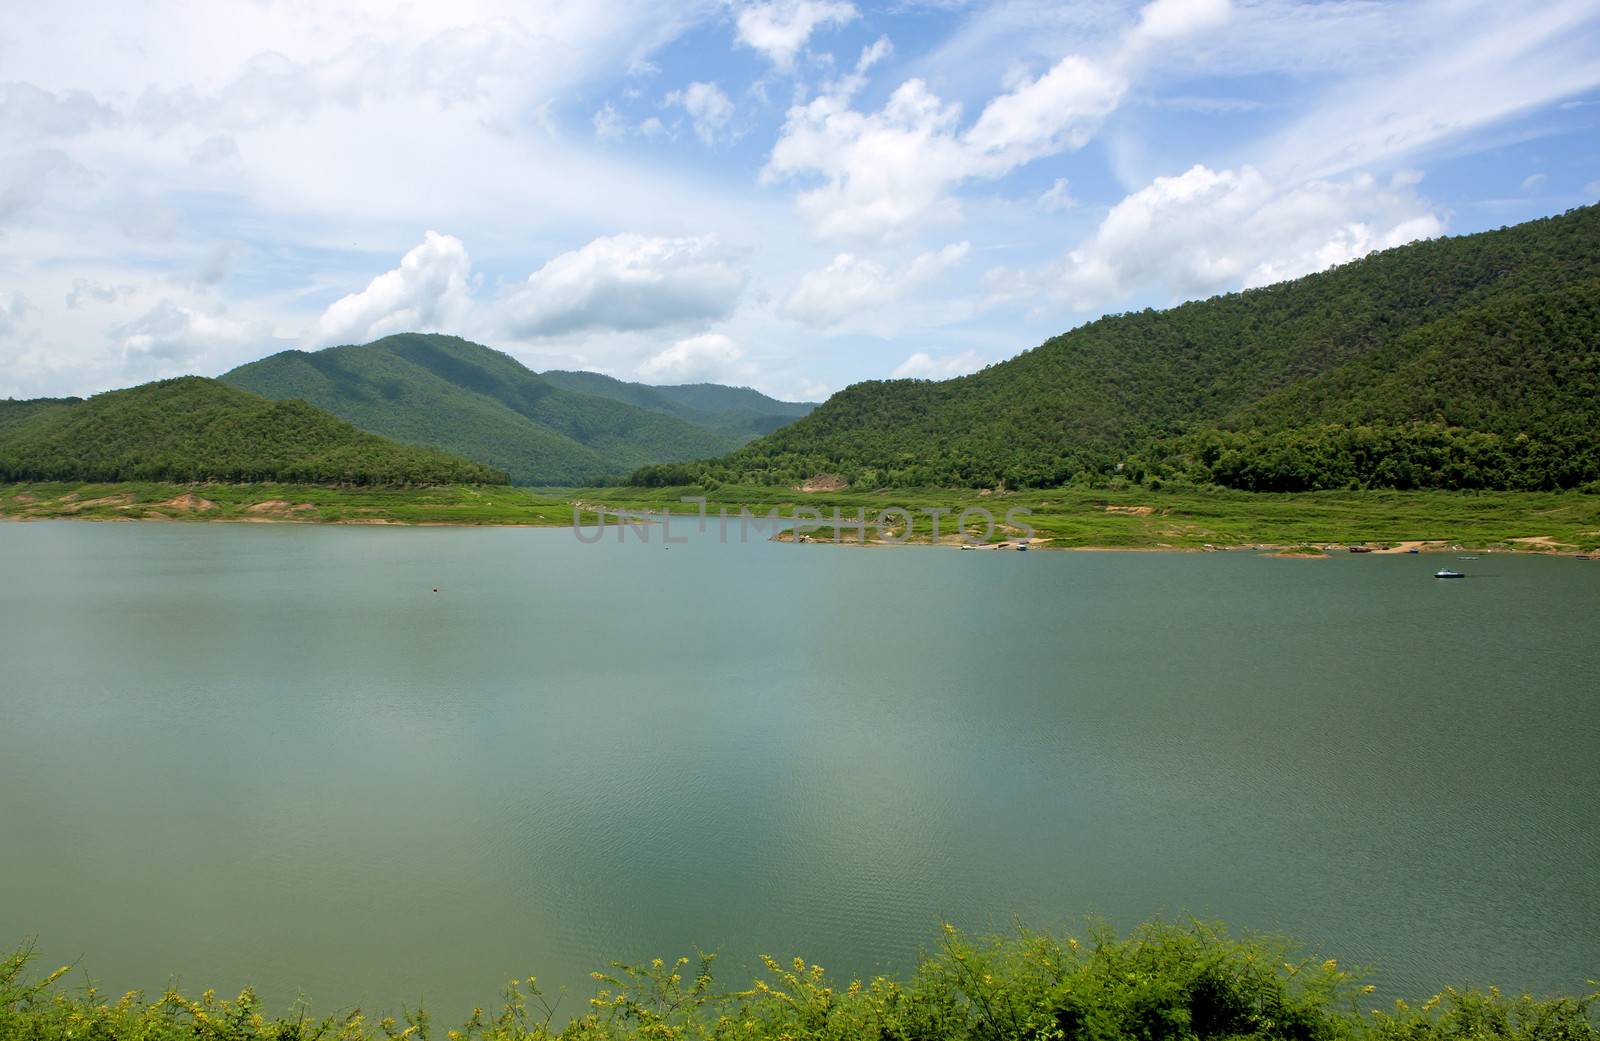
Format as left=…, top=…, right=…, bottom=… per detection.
left=222, top=333, right=800, bottom=485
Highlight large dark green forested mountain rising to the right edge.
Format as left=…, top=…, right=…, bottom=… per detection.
left=634, top=206, right=1600, bottom=491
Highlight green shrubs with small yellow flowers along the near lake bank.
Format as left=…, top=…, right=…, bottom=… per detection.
left=0, top=923, right=1600, bottom=1041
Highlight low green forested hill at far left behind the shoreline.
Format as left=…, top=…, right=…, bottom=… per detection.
left=0, top=376, right=507, bottom=485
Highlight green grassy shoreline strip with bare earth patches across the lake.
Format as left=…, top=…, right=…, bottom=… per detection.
left=0, top=483, right=1600, bottom=555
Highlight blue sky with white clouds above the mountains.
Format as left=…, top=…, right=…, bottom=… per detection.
left=0, top=0, right=1600, bottom=398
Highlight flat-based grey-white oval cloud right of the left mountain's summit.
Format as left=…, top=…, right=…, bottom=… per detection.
left=504, top=235, right=744, bottom=336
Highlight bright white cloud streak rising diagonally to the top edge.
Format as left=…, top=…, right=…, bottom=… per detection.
left=762, top=0, right=1229, bottom=238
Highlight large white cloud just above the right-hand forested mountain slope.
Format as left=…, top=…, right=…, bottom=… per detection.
left=1058, top=165, right=1445, bottom=310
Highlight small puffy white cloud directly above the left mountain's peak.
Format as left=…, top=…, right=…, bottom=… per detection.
left=312, top=232, right=472, bottom=344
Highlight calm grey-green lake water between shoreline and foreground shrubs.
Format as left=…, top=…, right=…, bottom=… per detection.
left=0, top=521, right=1600, bottom=1023
